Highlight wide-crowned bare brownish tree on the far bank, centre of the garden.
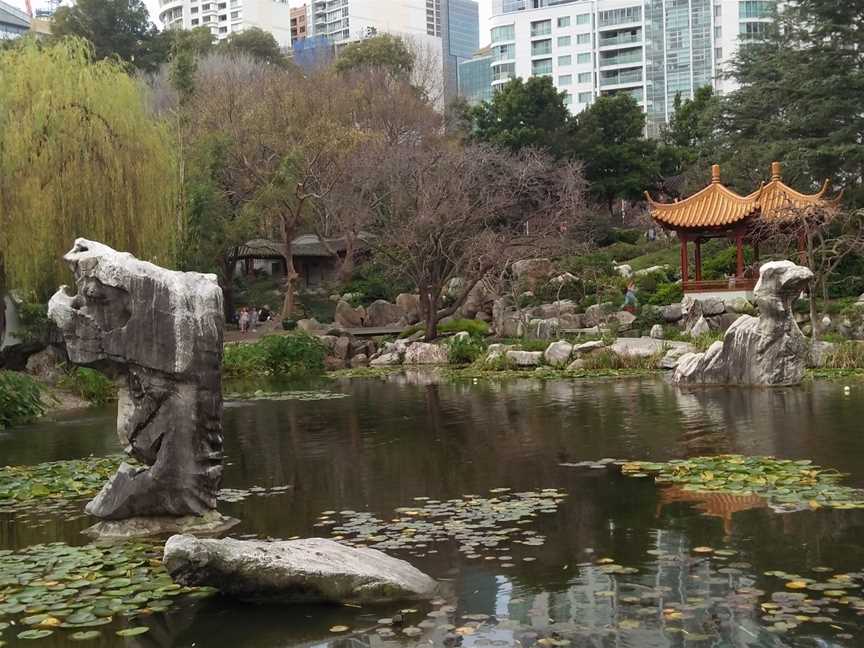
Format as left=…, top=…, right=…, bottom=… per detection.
left=358, top=141, right=585, bottom=340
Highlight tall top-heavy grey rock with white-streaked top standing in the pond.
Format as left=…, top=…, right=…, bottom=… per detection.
left=48, top=239, right=223, bottom=520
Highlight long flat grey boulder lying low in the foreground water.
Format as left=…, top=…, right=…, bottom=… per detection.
left=163, top=535, right=438, bottom=605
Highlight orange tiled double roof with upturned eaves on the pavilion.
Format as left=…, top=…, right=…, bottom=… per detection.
left=645, top=162, right=842, bottom=229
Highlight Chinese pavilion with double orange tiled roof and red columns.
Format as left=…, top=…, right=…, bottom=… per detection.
left=645, top=162, right=840, bottom=299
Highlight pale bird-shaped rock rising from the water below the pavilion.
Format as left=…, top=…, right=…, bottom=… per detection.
left=674, top=261, right=813, bottom=386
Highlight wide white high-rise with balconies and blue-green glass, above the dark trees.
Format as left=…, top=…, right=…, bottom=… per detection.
left=490, top=0, right=776, bottom=134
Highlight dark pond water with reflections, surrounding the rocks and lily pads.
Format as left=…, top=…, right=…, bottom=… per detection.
left=0, top=373, right=864, bottom=648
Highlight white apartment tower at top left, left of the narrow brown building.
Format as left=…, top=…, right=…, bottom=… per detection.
left=159, top=0, right=291, bottom=48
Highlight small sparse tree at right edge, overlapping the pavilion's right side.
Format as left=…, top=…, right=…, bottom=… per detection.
left=753, top=205, right=864, bottom=344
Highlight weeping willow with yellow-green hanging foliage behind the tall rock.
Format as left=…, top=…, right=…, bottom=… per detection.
left=0, top=39, right=181, bottom=300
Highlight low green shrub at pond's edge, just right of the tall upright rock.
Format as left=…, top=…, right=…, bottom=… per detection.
left=222, top=333, right=327, bottom=377
